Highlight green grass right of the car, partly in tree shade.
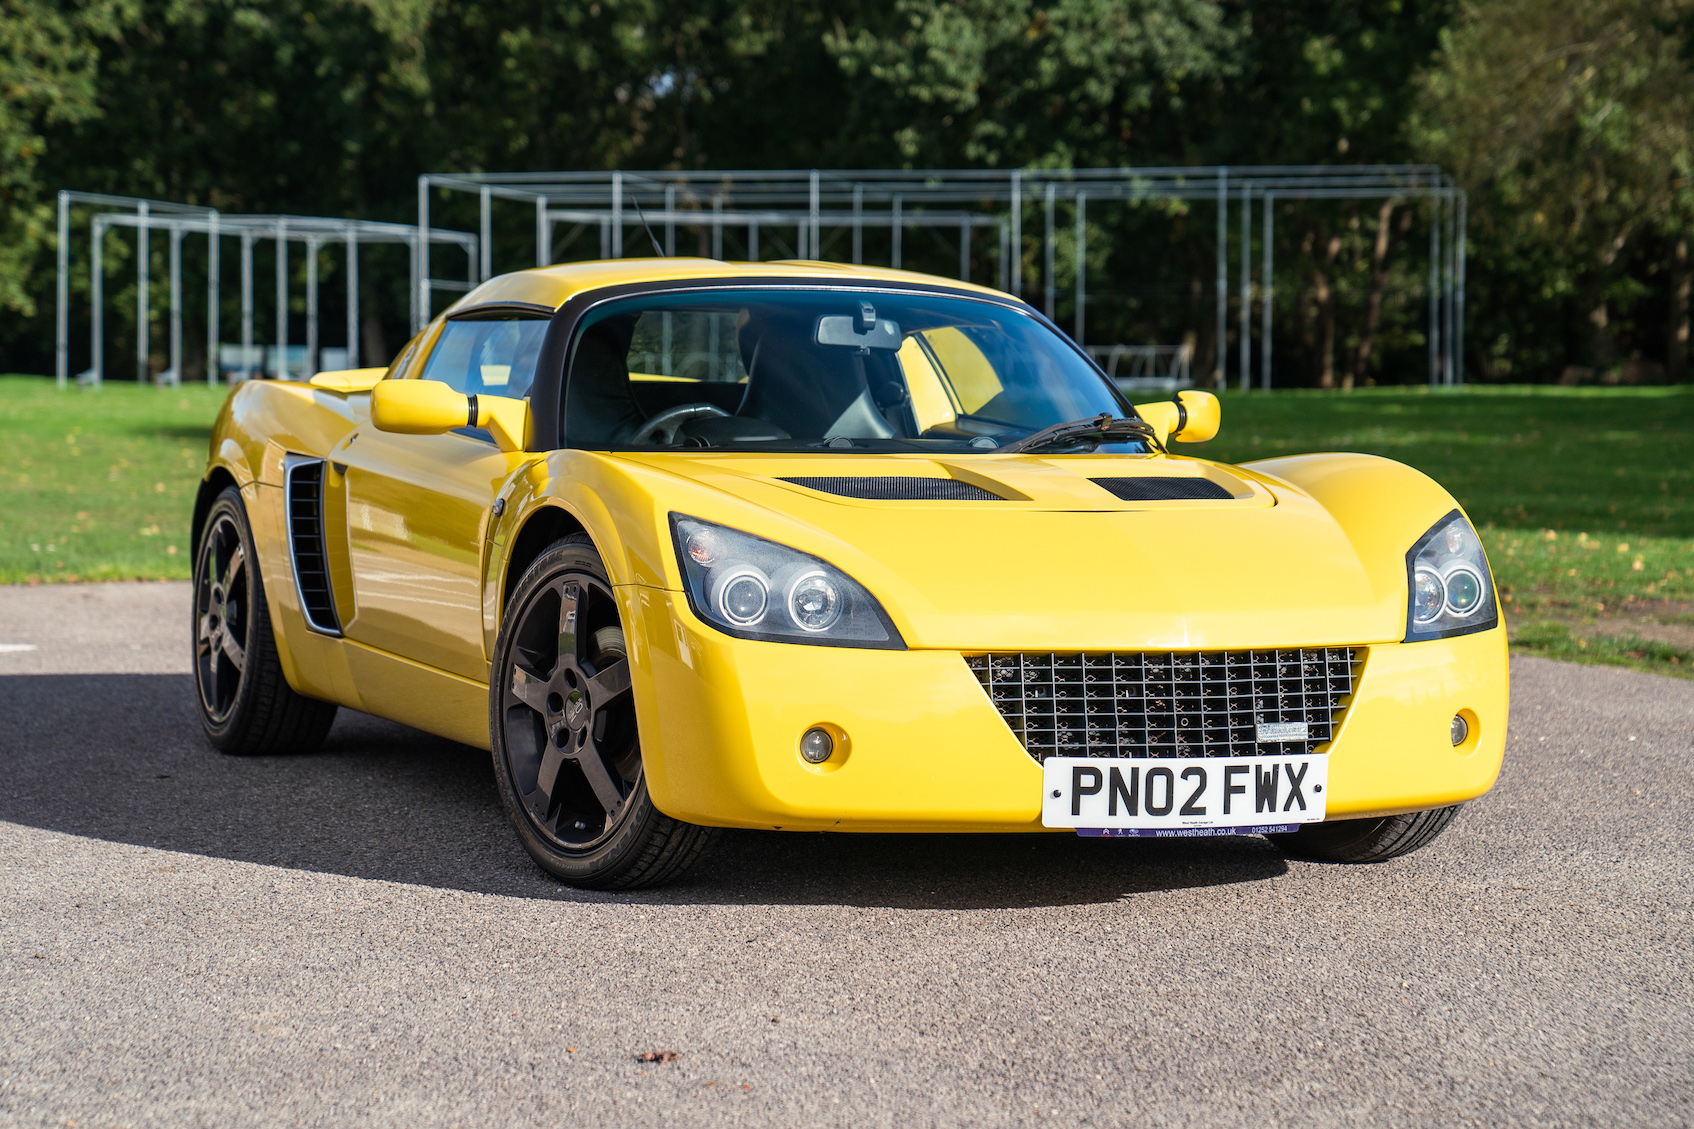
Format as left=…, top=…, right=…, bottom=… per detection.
left=1179, top=385, right=1694, bottom=675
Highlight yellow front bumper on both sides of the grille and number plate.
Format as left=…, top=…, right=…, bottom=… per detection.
left=618, top=585, right=1508, bottom=831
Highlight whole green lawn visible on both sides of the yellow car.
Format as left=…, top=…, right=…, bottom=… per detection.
left=0, top=376, right=1694, bottom=673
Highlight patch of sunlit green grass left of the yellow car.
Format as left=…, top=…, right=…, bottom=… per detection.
left=0, top=376, right=225, bottom=583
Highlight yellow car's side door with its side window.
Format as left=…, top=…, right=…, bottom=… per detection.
left=330, top=309, right=547, bottom=681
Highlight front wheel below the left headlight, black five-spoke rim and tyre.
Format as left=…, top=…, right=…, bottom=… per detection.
left=488, top=534, right=717, bottom=890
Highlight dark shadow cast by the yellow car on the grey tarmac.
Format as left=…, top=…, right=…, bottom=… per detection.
left=0, top=675, right=1287, bottom=909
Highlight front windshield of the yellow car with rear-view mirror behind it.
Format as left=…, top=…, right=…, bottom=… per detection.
left=564, top=288, right=1143, bottom=453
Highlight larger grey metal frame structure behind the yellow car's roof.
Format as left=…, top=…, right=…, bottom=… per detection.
left=413, top=164, right=1465, bottom=388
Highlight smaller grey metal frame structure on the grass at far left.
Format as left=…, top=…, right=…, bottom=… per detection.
left=56, top=192, right=479, bottom=388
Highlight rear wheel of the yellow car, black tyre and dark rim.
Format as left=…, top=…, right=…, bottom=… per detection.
left=193, top=487, right=335, bottom=756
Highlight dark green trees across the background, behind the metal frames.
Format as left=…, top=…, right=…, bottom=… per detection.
left=0, top=0, right=1694, bottom=387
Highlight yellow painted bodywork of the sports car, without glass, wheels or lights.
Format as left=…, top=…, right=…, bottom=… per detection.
left=198, top=259, right=1508, bottom=831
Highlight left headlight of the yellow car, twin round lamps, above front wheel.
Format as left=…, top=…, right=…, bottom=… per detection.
left=671, top=514, right=906, bottom=651
